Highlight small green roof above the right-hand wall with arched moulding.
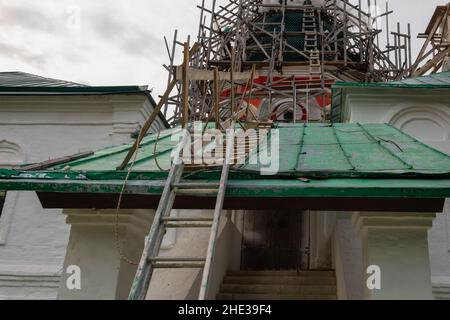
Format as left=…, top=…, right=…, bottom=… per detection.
left=333, top=71, right=450, bottom=89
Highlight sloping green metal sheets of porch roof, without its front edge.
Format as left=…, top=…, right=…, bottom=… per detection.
left=3, top=124, right=450, bottom=178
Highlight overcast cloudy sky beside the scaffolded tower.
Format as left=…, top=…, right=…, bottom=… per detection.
left=0, top=0, right=446, bottom=97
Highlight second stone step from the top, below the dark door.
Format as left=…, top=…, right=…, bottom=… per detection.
left=224, top=276, right=336, bottom=286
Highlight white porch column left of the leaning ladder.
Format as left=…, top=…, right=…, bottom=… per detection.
left=58, top=210, right=154, bottom=300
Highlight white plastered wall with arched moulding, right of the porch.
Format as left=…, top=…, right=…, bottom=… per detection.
left=345, top=89, right=450, bottom=299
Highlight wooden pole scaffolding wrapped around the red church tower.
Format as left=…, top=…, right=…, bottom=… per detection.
left=159, top=0, right=412, bottom=129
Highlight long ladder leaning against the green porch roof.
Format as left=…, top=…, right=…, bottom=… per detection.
left=128, top=125, right=234, bottom=300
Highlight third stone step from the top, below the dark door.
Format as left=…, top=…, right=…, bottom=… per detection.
left=220, top=284, right=336, bottom=295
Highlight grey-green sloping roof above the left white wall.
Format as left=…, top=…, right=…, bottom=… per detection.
left=0, top=71, right=87, bottom=88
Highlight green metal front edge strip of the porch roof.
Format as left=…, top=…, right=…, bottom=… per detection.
left=0, top=179, right=450, bottom=199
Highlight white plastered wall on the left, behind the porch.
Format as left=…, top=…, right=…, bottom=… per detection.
left=0, top=94, right=162, bottom=299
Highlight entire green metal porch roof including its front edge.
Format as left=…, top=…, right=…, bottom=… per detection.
left=0, top=124, right=450, bottom=197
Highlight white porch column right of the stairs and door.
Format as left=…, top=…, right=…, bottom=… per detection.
left=353, top=212, right=436, bottom=300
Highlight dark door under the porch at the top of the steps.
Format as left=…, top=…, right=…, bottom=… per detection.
left=241, top=211, right=309, bottom=270
